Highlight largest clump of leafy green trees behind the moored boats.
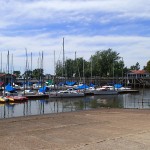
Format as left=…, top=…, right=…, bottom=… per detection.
left=56, top=49, right=125, bottom=77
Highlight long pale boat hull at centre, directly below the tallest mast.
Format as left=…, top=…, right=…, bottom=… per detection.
left=49, top=90, right=84, bottom=98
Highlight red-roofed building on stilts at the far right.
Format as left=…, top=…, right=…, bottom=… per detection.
left=127, top=70, right=150, bottom=79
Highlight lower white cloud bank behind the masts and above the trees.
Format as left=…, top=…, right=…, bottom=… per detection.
left=0, top=34, right=150, bottom=73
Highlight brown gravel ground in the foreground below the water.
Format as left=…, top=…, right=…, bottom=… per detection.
left=0, top=109, right=150, bottom=150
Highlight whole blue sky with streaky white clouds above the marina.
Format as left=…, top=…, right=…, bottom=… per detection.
left=0, top=0, right=150, bottom=74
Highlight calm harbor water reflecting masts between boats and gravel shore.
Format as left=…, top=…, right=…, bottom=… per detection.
left=0, top=89, right=150, bottom=119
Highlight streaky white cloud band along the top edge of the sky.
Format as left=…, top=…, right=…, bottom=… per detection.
left=0, top=0, right=150, bottom=28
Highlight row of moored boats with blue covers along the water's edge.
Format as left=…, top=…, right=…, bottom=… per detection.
left=0, top=84, right=134, bottom=103
